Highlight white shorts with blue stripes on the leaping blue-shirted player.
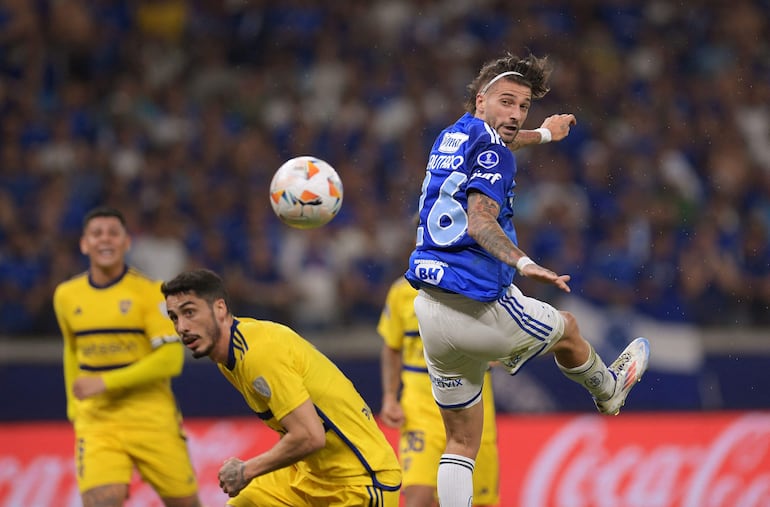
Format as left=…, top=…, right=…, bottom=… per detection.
left=414, top=285, right=564, bottom=408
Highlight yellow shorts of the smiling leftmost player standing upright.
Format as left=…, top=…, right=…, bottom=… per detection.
left=75, top=426, right=198, bottom=498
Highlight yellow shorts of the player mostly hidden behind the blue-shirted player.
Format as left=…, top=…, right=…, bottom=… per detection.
left=398, top=372, right=500, bottom=505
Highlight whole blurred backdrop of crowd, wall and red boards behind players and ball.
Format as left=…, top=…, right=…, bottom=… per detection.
left=0, top=0, right=770, bottom=507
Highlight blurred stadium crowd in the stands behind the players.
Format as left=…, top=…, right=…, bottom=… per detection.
left=0, top=0, right=770, bottom=336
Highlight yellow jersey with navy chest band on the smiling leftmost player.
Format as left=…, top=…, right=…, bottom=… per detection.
left=53, top=267, right=184, bottom=428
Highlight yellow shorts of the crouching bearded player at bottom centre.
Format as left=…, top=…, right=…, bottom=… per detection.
left=227, top=466, right=399, bottom=507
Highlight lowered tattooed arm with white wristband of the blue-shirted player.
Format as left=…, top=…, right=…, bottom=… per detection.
left=468, top=191, right=570, bottom=292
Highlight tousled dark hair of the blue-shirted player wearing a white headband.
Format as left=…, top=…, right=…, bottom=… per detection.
left=465, top=53, right=553, bottom=114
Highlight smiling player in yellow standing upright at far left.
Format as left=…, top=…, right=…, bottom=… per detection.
left=54, top=207, right=201, bottom=507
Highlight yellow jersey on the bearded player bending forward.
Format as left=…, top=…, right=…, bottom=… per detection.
left=218, top=318, right=401, bottom=491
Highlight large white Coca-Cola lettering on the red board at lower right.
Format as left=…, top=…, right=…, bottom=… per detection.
left=514, top=414, right=770, bottom=507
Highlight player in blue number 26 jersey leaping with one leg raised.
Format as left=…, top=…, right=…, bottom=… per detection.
left=406, top=54, right=649, bottom=507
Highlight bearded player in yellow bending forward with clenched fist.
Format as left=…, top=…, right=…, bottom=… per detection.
left=161, top=269, right=401, bottom=507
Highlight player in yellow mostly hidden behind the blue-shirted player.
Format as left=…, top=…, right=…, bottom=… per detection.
left=377, top=278, right=500, bottom=507
